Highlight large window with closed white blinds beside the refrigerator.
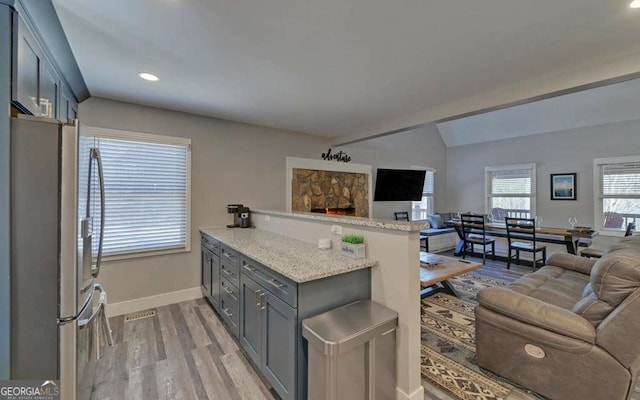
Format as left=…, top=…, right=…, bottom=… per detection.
left=96, top=130, right=191, bottom=256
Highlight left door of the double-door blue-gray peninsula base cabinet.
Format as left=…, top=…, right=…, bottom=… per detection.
left=239, top=274, right=265, bottom=367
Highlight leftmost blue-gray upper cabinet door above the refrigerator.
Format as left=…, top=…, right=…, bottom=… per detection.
left=11, top=14, right=43, bottom=116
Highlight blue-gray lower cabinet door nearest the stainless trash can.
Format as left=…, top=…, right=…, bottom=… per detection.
left=261, top=291, right=297, bottom=400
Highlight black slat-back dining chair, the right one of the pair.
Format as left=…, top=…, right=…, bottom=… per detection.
left=504, top=218, right=547, bottom=271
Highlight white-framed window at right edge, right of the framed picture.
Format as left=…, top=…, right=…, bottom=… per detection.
left=594, top=156, right=640, bottom=232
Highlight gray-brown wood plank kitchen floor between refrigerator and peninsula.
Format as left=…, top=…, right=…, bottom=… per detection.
left=91, top=299, right=278, bottom=400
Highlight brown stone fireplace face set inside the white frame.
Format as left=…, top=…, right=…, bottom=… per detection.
left=291, top=168, right=369, bottom=217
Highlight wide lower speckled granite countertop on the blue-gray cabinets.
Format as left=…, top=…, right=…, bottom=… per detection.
left=200, top=228, right=378, bottom=283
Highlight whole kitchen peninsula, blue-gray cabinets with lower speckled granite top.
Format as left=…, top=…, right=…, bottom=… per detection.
left=200, top=228, right=378, bottom=399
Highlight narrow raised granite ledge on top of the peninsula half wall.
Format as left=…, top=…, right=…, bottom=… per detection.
left=251, top=210, right=428, bottom=232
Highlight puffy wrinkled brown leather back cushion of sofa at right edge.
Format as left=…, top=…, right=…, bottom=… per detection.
left=591, top=252, right=640, bottom=307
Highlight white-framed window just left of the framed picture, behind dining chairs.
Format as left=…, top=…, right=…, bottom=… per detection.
left=485, top=164, right=536, bottom=218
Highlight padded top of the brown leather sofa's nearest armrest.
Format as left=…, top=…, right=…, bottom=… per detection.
left=478, top=287, right=596, bottom=344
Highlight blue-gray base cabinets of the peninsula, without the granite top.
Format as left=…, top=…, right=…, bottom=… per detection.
left=201, top=233, right=371, bottom=400
